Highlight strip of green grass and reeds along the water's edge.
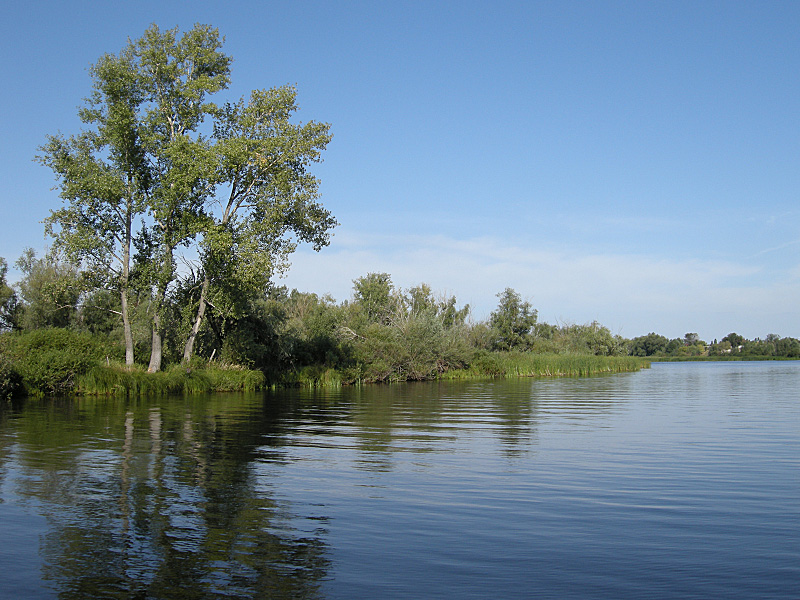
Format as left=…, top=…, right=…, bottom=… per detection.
left=0, top=329, right=650, bottom=398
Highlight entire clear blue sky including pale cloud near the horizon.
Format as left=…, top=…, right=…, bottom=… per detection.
left=0, top=0, right=800, bottom=341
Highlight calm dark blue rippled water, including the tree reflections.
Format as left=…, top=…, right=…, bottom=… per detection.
left=0, top=362, right=800, bottom=599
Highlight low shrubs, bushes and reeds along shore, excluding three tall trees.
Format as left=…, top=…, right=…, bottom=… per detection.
left=0, top=262, right=800, bottom=398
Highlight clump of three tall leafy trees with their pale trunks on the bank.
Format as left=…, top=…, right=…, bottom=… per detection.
left=38, top=25, right=336, bottom=370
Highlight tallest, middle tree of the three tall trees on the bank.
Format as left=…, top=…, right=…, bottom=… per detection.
left=129, top=25, right=231, bottom=371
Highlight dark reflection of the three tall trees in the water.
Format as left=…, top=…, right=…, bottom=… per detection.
left=3, top=396, right=328, bottom=599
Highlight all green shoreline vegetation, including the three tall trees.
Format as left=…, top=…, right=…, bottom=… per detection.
left=0, top=25, right=800, bottom=398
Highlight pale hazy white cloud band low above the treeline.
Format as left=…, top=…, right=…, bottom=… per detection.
left=284, top=231, right=800, bottom=340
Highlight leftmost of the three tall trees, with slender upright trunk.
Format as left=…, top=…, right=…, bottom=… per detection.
left=38, top=48, right=151, bottom=365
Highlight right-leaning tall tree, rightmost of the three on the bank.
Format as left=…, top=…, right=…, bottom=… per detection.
left=183, top=86, right=336, bottom=360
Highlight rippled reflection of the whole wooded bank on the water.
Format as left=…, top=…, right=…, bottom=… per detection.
left=0, top=379, right=624, bottom=599
